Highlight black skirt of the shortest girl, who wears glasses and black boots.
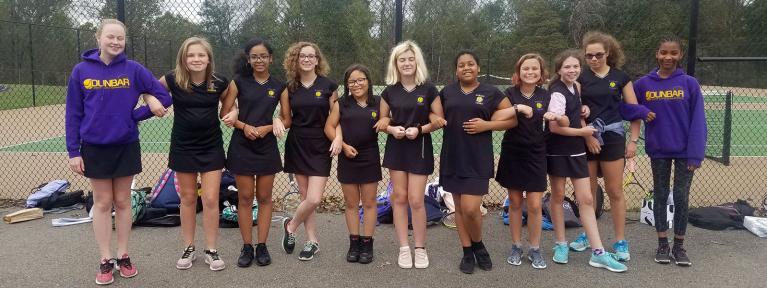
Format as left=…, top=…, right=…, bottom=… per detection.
left=338, top=146, right=383, bottom=184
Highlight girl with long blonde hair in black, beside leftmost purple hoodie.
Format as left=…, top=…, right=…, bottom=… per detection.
left=160, top=37, right=229, bottom=271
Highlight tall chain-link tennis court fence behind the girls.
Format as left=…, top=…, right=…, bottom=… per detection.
left=0, top=0, right=767, bottom=212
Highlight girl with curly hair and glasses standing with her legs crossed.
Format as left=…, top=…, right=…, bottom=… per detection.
left=280, top=42, right=342, bottom=261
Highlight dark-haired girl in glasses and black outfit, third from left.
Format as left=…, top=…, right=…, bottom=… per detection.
left=222, top=38, right=286, bottom=267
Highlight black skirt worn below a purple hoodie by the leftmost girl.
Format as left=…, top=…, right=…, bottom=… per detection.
left=80, top=141, right=141, bottom=179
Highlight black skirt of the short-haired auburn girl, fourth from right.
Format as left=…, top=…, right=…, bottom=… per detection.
left=495, top=151, right=546, bottom=192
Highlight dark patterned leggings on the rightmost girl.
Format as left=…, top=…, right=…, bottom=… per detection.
left=650, top=158, right=694, bottom=236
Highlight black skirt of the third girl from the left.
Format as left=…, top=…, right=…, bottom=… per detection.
left=226, top=130, right=282, bottom=176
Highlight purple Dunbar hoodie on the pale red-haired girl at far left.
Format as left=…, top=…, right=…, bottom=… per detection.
left=65, top=49, right=172, bottom=158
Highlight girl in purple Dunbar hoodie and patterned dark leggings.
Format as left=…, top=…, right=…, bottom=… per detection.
left=634, top=37, right=707, bottom=266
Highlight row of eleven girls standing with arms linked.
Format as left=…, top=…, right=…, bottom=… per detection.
left=66, top=19, right=706, bottom=284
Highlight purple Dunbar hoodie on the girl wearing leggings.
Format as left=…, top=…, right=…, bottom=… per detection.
left=634, top=68, right=707, bottom=166
